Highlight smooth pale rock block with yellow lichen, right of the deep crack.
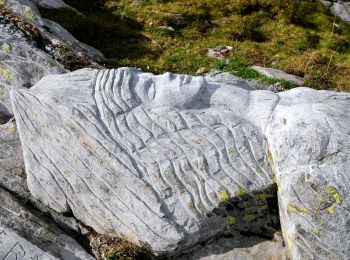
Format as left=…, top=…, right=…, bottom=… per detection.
left=265, top=88, right=350, bottom=259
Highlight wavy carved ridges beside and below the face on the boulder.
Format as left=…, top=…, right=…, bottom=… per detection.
left=94, top=70, right=271, bottom=248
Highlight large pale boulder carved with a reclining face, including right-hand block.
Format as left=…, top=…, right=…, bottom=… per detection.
left=12, top=68, right=350, bottom=259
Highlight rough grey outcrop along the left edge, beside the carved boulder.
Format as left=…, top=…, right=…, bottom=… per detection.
left=0, top=1, right=110, bottom=259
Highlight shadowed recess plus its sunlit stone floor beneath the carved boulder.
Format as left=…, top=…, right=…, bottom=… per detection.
left=175, top=185, right=285, bottom=260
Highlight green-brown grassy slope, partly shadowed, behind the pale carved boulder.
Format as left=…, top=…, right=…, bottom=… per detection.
left=41, top=0, right=350, bottom=91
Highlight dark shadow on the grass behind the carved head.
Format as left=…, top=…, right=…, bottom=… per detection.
left=40, top=0, right=157, bottom=66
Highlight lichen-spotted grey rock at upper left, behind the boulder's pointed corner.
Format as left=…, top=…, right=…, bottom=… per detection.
left=0, top=11, right=66, bottom=114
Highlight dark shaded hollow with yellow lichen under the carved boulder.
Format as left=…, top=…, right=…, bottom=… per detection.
left=167, top=184, right=281, bottom=259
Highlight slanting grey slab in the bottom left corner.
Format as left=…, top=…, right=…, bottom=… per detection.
left=0, top=188, right=93, bottom=259
